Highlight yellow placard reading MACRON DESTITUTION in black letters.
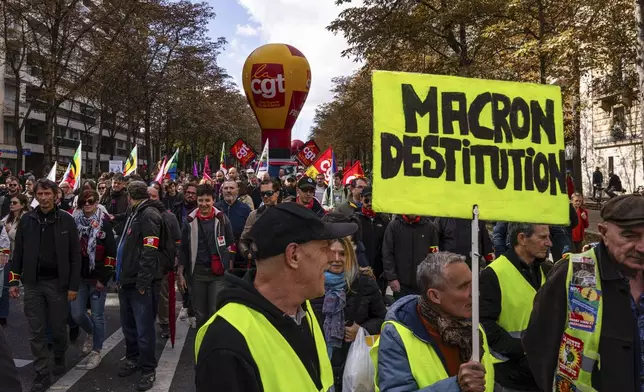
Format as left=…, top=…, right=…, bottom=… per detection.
left=373, top=71, right=569, bottom=225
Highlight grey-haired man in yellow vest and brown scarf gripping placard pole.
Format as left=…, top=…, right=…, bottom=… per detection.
left=371, top=252, right=494, bottom=392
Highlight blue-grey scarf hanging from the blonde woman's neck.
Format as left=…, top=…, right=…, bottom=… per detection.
left=322, top=271, right=347, bottom=351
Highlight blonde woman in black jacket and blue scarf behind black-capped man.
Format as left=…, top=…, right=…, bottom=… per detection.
left=312, top=237, right=387, bottom=391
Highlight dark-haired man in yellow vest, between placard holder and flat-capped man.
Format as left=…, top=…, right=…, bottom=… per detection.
left=480, top=223, right=552, bottom=392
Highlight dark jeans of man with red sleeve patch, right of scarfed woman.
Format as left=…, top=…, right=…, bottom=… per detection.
left=119, top=287, right=157, bottom=374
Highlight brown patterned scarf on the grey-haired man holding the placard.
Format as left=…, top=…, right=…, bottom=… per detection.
left=418, top=297, right=483, bottom=362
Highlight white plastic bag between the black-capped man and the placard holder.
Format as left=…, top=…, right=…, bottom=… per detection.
left=342, top=327, right=376, bottom=392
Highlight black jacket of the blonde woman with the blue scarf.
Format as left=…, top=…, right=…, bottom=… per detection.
left=311, top=272, right=387, bottom=391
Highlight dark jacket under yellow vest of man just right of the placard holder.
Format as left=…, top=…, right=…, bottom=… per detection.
left=479, top=249, right=547, bottom=391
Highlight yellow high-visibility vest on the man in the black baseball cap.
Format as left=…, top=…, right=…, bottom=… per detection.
left=195, top=301, right=333, bottom=392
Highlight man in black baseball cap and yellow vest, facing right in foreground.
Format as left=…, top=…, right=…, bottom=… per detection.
left=195, top=203, right=358, bottom=392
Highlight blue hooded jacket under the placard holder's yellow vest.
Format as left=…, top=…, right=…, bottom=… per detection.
left=377, top=295, right=461, bottom=392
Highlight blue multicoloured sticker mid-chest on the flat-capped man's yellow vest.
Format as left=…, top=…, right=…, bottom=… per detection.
left=568, top=286, right=601, bottom=332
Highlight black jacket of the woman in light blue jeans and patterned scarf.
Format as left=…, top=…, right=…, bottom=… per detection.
left=81, top=216, right=116, bottom=286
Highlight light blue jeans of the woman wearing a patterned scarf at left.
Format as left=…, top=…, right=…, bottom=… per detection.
left=71, top=280, right=107, bottom=352
